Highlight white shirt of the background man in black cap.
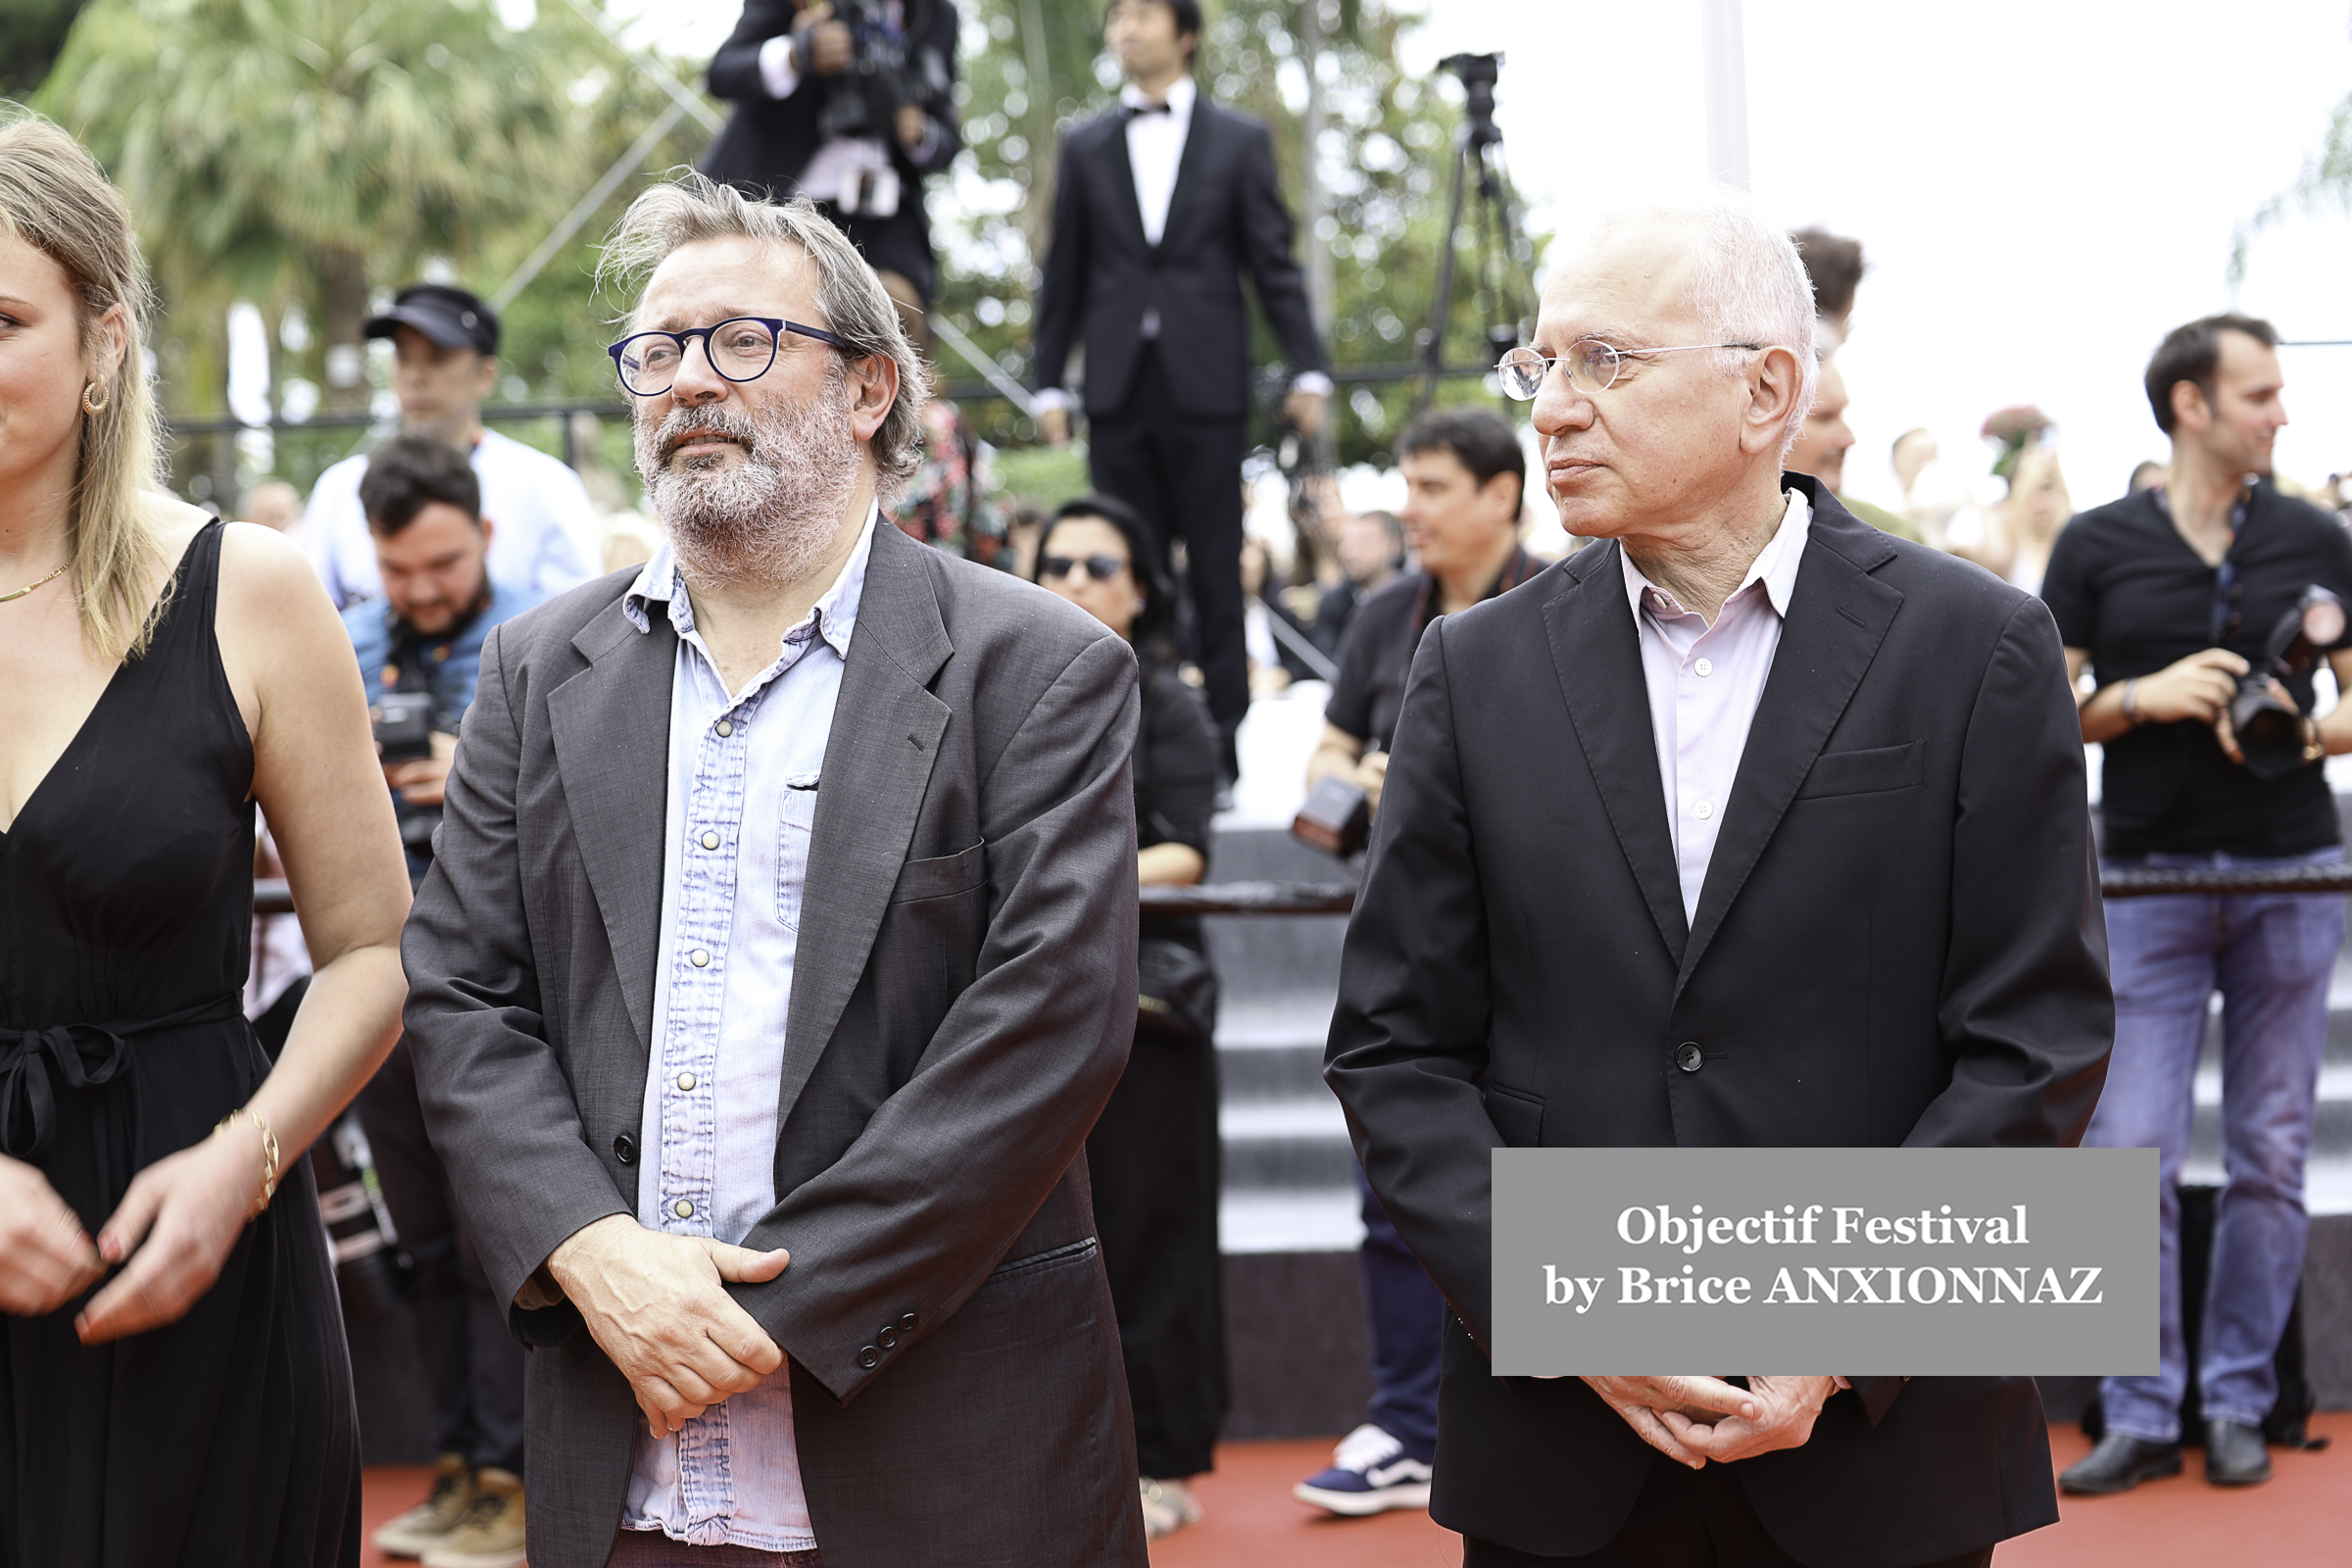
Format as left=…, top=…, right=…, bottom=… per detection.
left=304, top=430, right=605, bottom=609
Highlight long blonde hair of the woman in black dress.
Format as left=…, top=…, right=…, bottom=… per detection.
left=0, top=113, right=172, bottom=662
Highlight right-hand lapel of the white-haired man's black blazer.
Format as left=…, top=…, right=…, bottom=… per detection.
left=1675, top=521, right=1903, bottom=997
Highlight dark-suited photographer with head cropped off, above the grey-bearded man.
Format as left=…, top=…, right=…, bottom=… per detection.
left=704, top=0, right=959, bottom=355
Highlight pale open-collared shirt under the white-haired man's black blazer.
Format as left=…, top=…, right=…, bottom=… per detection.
left=1618, top=491, right=1813, bottom=921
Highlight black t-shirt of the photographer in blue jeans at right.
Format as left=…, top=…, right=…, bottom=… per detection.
left=2041, top=482, right=2352, bottom=856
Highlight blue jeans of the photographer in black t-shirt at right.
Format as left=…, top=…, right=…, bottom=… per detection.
left=2083, top=849, right=2345, bottom=1444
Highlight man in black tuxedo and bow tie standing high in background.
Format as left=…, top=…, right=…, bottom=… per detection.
left=1035, top=0, right=1331, bottom=776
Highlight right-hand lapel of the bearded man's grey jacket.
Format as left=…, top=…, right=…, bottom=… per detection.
left=776, top=517, right=955, bottom=1126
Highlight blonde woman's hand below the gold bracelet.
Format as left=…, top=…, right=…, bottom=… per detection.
left=73, top=1116, right=261, bottom=1345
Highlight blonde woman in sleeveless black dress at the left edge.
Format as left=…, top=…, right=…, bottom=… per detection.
left=0, top=118, right=410, bottom=1568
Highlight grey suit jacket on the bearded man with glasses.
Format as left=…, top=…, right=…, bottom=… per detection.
left=402, top=524, right=1146, bottom=1568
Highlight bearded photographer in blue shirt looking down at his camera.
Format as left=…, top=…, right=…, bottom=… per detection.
left=343, top=432, right=541, bottom=1568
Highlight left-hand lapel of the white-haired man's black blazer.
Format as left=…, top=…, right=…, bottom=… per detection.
left=1543, top=541, right=1719, bottom=964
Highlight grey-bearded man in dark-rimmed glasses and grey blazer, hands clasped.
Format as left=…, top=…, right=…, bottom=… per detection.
left=402, top=174, right=1146, bottom=1568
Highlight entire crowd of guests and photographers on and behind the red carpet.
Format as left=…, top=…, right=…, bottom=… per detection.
left=0, top=0, right=2352, bottom=1568
